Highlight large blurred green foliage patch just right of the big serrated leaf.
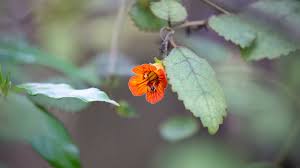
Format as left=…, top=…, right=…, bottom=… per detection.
left=217, top=63, right=294, bottom=146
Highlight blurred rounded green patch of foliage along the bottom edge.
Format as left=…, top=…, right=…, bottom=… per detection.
left=155, top=137, right=244, bottom=168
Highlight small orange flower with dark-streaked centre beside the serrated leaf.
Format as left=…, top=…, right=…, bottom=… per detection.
left=128, top=63, right=168, bottom=104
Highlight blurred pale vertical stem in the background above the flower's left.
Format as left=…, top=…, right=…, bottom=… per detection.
left=108, top=0, right=126, bottom=75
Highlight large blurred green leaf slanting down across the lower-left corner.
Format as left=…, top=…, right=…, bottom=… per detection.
left=0, top=93, right=81, bottom=168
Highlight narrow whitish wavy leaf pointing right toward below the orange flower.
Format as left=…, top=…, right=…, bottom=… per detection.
left=18, top=83, right=119, bottom=106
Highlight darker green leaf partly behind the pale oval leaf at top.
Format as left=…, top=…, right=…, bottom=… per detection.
left=129, top=2, right=167, bottom=31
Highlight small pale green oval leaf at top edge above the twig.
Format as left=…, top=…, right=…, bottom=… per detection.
left=150, top=0, right=187, bottom=23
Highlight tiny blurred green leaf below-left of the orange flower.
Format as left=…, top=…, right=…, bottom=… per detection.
left=117, top=100, right=138, bottom=118
